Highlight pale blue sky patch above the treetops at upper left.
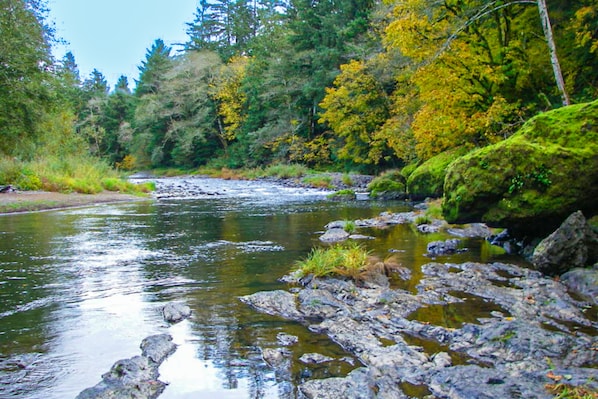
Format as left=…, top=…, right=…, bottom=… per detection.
left=48, top=0, right=198, bottom=89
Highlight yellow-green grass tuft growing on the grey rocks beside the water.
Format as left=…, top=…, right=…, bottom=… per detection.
left=296, top=243, right=369, bottom=280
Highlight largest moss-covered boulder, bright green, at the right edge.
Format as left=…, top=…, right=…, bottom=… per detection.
left=443, top=101, right=598, bottom=236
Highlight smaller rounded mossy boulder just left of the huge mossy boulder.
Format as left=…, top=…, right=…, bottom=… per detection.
left=407, top=148, right=468, bottom=200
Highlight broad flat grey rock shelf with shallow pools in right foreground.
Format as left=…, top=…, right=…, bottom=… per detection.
left=240, top=213, right=598, bottom=399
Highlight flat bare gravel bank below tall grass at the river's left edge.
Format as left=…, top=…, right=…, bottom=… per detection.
left=0, top=191, right=148, bottom=214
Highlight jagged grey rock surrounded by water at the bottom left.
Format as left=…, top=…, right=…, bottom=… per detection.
left=77, top=334, right=176, bottom=399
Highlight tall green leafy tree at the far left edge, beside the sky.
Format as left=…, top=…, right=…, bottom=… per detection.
left=0, top=0, right=53, bottom=157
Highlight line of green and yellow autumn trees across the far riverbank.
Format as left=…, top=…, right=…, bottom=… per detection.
left=0, top=0, right=598, bottom=173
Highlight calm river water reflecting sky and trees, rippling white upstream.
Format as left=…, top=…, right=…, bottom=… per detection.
left=0, top=178, right=516, bottom=399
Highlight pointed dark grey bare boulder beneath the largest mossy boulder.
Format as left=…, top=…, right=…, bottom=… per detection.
left=531, top=211, right=598, bottom=275
